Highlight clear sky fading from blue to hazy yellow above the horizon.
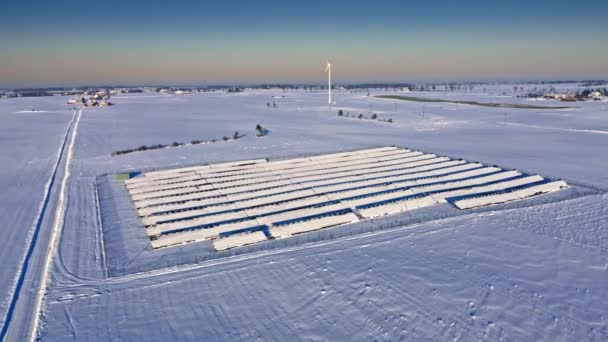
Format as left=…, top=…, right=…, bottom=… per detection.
left=0, top=0, right=608, bottom=86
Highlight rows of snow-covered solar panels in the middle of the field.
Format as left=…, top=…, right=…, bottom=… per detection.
left=126, top=147, right=567, bottom=250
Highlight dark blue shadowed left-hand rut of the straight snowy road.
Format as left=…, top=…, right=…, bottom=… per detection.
left=0, top=110, right=81, bottom=340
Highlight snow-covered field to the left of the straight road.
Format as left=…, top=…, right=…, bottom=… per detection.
left=0, top=98, right=72, bottom=340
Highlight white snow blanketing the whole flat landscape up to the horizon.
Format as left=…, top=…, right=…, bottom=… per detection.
left=0, top=89, right=608, bottom=341
